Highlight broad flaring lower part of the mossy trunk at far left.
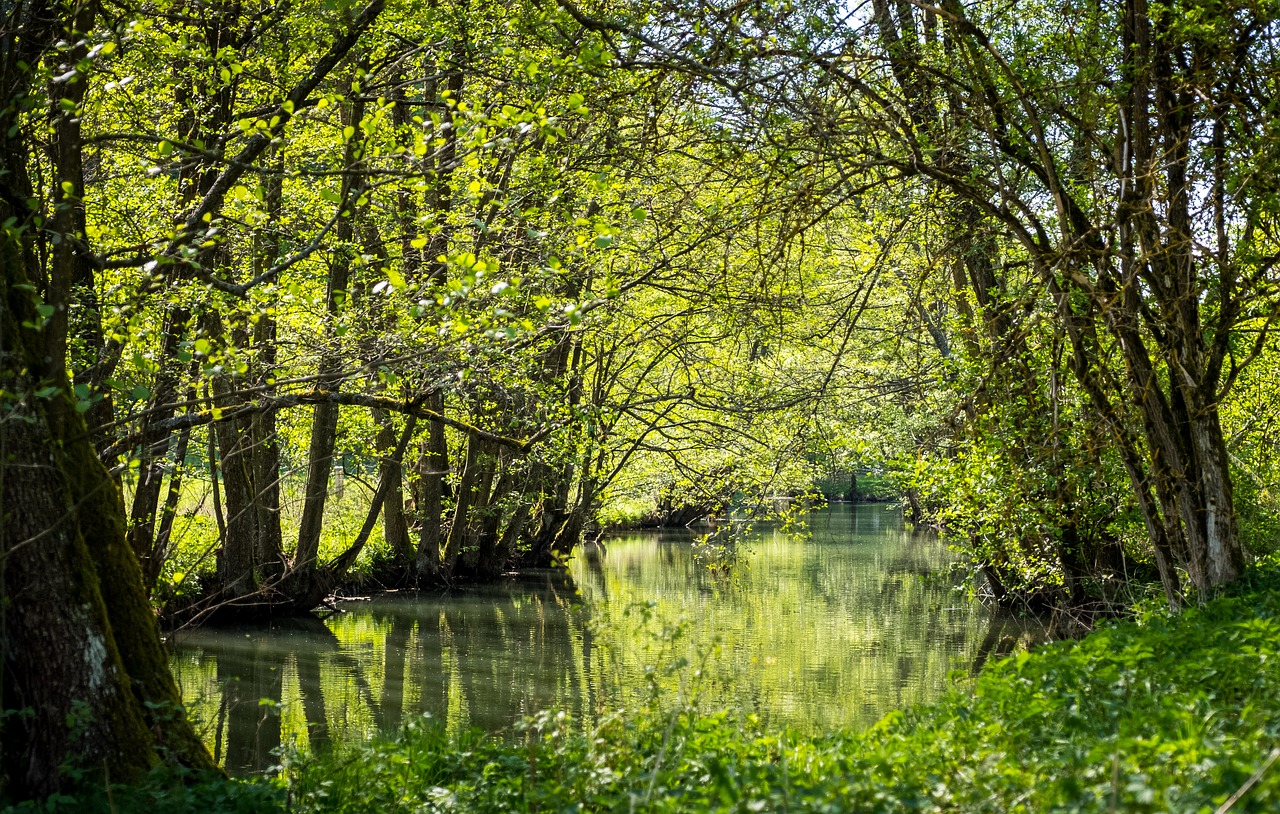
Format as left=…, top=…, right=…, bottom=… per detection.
left=0, top=225, right=212, bottom=799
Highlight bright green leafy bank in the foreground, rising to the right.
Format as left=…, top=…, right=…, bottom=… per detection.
left=20, top=564, right=1280, bottom=814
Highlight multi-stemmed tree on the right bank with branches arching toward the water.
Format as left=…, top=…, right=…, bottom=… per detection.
left=581, top=0, right=1280, bottom=603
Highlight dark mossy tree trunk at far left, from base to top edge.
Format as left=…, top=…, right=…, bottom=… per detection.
left=0, top=6, right=222, bottom=799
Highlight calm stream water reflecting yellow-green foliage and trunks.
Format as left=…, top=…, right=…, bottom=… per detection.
left=172, top=506, right=1000, bottom=772
